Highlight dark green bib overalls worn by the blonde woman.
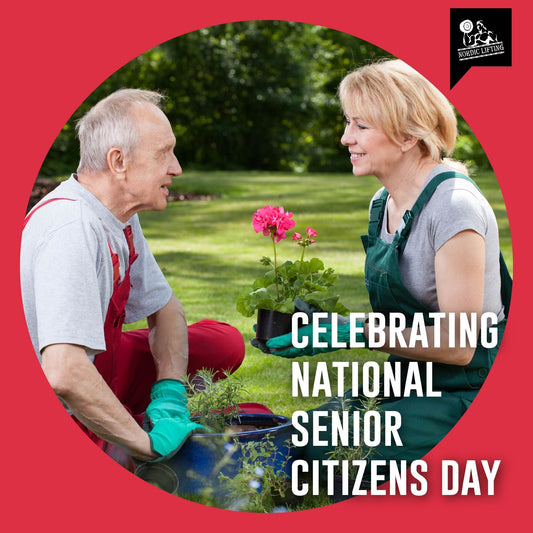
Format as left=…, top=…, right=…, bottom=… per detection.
left=304, top=172, right=512, bottom=476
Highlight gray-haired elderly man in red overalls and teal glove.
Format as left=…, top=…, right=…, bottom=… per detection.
left=21, top=89, right=244, bottom=466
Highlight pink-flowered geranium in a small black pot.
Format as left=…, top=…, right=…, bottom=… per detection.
left=237, top=205, right=349, bottom=340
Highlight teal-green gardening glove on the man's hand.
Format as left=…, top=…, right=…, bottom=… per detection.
left=143, top=379, right=204, bottom=462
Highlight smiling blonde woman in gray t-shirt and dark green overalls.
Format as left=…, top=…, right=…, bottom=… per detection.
left=267, top=60, right=511, bottom=482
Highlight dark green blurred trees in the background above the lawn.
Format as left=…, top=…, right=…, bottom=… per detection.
left=41, top=21, right=483, bottom=176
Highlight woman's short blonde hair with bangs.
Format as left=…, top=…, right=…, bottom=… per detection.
left=339, top=59, right=457, bottom=162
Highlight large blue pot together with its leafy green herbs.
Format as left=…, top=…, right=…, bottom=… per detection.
left=135, top=369, right=292, bottom=510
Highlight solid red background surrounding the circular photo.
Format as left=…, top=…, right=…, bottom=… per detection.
left=0, top=0, right=533, bottom=533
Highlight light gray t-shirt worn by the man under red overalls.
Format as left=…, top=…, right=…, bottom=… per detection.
left=20, top=175, right=172, bottom=361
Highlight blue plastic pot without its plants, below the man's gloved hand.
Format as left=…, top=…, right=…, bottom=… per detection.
left=136, top=413, right=292, bottom=501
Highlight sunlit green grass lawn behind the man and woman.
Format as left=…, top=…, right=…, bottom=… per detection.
left=128, top=172, right=512, bottom=416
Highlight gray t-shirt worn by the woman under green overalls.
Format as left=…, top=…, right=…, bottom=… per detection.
left=372, top=165, right=504, bottom=320
